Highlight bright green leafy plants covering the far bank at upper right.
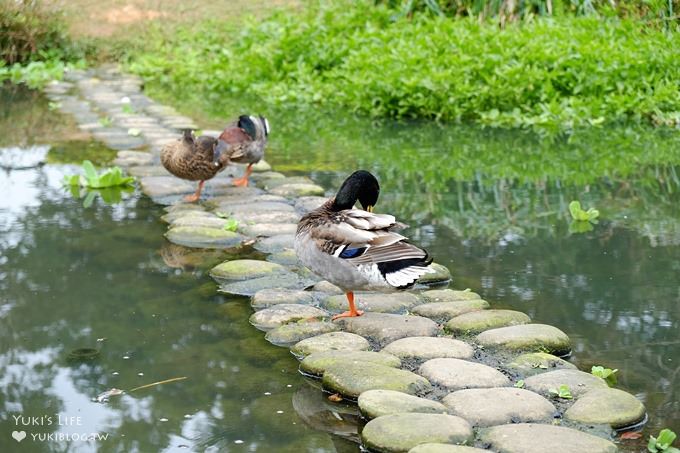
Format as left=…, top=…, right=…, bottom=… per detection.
left=130, top=1, right=680, bottom=131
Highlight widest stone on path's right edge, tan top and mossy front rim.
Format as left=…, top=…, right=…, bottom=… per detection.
left=477, top=324, right=571, bottom=355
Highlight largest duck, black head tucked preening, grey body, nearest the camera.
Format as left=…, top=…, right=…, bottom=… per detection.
left=295, top=170, right=432, bottom=319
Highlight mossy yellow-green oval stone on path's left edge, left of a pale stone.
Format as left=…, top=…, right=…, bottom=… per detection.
left=322, top=358, right=432, bottom=398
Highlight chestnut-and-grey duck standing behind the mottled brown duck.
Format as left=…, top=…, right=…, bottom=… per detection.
left=219, top=115, right=269, bottom=187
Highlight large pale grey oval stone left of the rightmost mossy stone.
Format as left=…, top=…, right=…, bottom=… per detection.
left=442, top=387, right=556, bottom=426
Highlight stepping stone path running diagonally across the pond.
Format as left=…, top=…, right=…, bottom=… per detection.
left=44, top=67, right=645, bottom=453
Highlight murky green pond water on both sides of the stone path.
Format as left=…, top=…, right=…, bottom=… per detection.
left=0, top=82, right=680, bottom=452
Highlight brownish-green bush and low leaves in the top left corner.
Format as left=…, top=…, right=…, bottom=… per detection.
left=0, top=0, right=88, bottom=87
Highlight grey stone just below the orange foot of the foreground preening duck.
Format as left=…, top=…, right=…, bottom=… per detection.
left=337, top=313, right=439, bottom=345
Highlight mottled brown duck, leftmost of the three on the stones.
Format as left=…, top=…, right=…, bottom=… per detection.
left=161, top=129, right=230, bottom=202
